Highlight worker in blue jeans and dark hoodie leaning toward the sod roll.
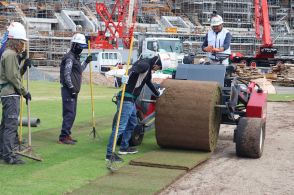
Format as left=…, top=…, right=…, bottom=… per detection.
left=105, top=56, right=165, bottom=162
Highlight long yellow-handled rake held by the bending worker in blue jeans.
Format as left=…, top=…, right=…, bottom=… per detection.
left=106, top=36, right=134, bottom=172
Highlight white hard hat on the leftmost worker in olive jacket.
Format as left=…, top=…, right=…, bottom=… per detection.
left=7, top=22, right=28, bottom=41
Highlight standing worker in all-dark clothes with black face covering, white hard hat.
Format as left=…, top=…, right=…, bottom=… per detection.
left=58, top=33, right=92, bottom=145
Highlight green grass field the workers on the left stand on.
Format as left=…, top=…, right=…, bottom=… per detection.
left=0, top=81, right=157, bottom=194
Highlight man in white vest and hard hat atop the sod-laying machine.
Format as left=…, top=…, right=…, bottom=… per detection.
left=202, top=12, right=232, bottom=65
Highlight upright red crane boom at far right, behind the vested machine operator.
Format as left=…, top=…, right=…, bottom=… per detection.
left=255, top=0, right=277, bottom=58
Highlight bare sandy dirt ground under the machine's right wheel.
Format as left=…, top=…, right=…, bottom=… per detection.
left=161, top=102, right=294, bottom=195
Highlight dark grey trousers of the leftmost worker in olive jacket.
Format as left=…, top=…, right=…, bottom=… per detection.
left=0, top=96, right=20, bottom=161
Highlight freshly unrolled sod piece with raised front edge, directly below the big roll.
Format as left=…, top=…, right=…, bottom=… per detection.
left=130, top=149, right=211, bottom=170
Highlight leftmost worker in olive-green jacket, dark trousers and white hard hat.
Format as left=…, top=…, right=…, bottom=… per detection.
left=0, top=22, right=31, bottom=164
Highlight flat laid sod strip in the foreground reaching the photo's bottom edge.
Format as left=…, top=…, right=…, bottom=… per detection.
left=68, top=165, right=186, bottom=195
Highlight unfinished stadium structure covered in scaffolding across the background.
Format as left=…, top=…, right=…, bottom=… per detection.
left=0, top=0, right=294, bottom=66
